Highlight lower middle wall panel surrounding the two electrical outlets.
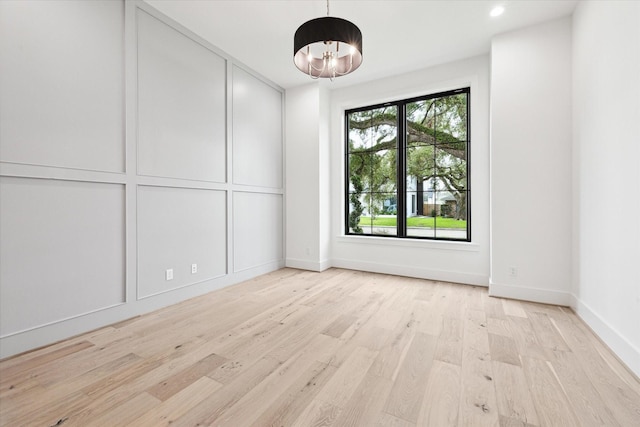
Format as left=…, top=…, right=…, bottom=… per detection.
left=138, top=186, right=227, bottom=298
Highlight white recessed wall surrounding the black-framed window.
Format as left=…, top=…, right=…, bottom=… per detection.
left=329, top=56, right=489, bottom=286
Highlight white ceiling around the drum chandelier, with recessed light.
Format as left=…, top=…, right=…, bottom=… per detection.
left=146, top=0, right=578, bottom=88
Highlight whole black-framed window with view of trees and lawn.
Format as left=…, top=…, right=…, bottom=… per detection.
left=345, top=88, right=471, bottom=241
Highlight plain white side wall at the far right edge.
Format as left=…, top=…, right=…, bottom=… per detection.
left=572, top=1, right=640, bottom=376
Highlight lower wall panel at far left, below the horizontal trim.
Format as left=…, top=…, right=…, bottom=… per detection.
left=0, top=176, right=125, bottom=336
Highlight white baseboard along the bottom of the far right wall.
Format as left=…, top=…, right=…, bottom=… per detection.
left=571, top=295, right=640, bottom=378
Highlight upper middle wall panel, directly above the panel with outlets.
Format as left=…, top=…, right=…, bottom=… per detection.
left=137, top=11, right=226, bottom=182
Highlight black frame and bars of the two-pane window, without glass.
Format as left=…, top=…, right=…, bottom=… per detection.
left=344, top=86, right=471, bottom=242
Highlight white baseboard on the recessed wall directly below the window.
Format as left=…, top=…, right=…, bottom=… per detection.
left=331, top=258, right=489, bottom=287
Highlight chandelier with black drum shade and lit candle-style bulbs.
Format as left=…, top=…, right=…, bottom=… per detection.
left=293, top=0, right=362, bottom=80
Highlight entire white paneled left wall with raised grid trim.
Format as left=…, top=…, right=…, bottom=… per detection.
left=0, top=0, right=284, bottom=357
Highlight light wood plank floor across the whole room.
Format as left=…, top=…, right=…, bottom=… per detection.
left=0, top=269, right=640, bottom=427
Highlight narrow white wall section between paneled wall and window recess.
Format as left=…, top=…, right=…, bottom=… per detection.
left=286, top=83, right=331, bottom=271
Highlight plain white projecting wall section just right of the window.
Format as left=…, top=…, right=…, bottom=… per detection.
left=490, top=18, right=572, bottom=305
